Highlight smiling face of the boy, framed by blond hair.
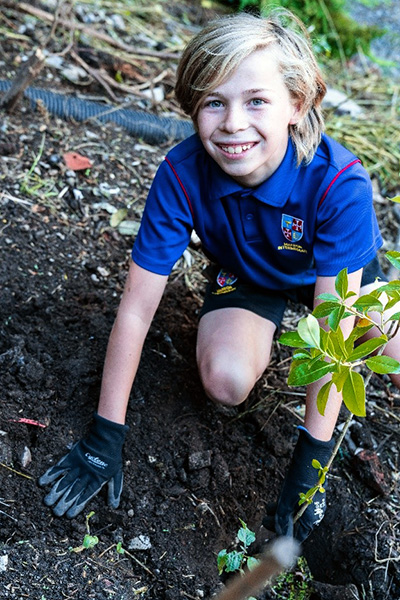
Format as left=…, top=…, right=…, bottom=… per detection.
left=197, top=48, right=301, bottom=187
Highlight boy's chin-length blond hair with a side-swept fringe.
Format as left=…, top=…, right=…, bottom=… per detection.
left=175, top=10, right=326, bottom=165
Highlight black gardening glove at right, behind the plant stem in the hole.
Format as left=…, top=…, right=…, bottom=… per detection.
left=264, top=427, right=334, bottom=542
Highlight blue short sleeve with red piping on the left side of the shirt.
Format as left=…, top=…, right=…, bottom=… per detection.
left=132, top=160, right=193, bottom=275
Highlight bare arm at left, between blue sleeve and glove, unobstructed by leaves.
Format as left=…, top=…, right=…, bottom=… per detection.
left=98, top=262, right=168, bottom=423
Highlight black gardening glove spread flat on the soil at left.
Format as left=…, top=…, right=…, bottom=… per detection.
left=39, top=413, right=129, bottom=519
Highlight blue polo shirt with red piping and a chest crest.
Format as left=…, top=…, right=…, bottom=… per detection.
left=132, top=134, right=382, bottom=289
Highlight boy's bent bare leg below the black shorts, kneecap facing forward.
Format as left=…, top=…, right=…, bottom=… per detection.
left=197, top=308, right=276, bottom=406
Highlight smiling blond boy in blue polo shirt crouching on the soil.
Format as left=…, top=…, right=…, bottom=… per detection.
left=40, top=13, right=397, bottom=540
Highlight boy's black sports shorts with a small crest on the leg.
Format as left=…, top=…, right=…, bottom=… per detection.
left=200, top=257, right=387, bottom=329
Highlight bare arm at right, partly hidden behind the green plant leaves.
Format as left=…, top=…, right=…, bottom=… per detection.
left=304, top=269, right=362, bottom=441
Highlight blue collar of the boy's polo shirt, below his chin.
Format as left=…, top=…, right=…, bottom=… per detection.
left=210, top=138, right=300, bottom=206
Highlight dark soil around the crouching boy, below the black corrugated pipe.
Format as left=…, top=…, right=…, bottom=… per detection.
left=0, top=1, right=400, bottom=600
